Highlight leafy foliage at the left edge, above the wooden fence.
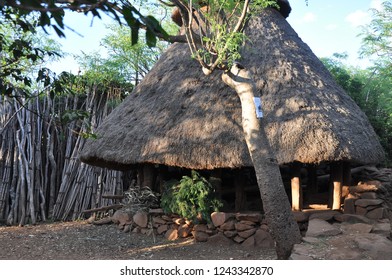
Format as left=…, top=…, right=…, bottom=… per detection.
left=0, top=8, right=61, bottom=96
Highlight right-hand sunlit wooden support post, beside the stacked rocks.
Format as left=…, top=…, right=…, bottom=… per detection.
left=328, top=161, right=343, bottom=210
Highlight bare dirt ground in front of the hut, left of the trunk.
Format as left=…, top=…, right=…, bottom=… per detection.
left=0, top=221, right=276, bottom=260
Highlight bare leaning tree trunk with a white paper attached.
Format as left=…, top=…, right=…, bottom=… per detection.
left=222, top=64, right=301, bottom=259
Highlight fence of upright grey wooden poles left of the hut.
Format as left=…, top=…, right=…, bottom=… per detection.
left=0, top=88, right=129, bottom=225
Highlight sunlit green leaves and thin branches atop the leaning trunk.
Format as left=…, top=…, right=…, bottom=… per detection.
left=171, top=0, right=277, bottom=74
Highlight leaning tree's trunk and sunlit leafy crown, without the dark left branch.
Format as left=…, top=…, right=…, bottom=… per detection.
left=164, top=0, right=301, bottom=259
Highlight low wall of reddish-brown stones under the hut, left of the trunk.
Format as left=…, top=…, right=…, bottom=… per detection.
left=97, top=209, right=274, bottom=248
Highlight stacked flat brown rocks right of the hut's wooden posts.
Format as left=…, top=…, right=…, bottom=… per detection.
left=343, top=181, right=388, bottom=220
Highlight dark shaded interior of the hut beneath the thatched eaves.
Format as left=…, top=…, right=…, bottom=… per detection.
left=133, top=163, right=362, bottom=212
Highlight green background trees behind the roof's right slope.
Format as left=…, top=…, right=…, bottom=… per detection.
left=321, top=1, right=392, bottom=166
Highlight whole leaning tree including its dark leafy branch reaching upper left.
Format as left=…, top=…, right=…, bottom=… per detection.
left=0, top=0, right=301, bottom=259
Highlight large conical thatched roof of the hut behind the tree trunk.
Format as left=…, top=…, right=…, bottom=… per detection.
left=81, top=9, right=383, bottom=169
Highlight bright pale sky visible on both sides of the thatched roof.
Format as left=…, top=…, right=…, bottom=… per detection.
left=49, top=0, right=390, bottom=74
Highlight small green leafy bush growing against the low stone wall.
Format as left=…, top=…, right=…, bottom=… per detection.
left=161, top=171, right=222, bottom=222
